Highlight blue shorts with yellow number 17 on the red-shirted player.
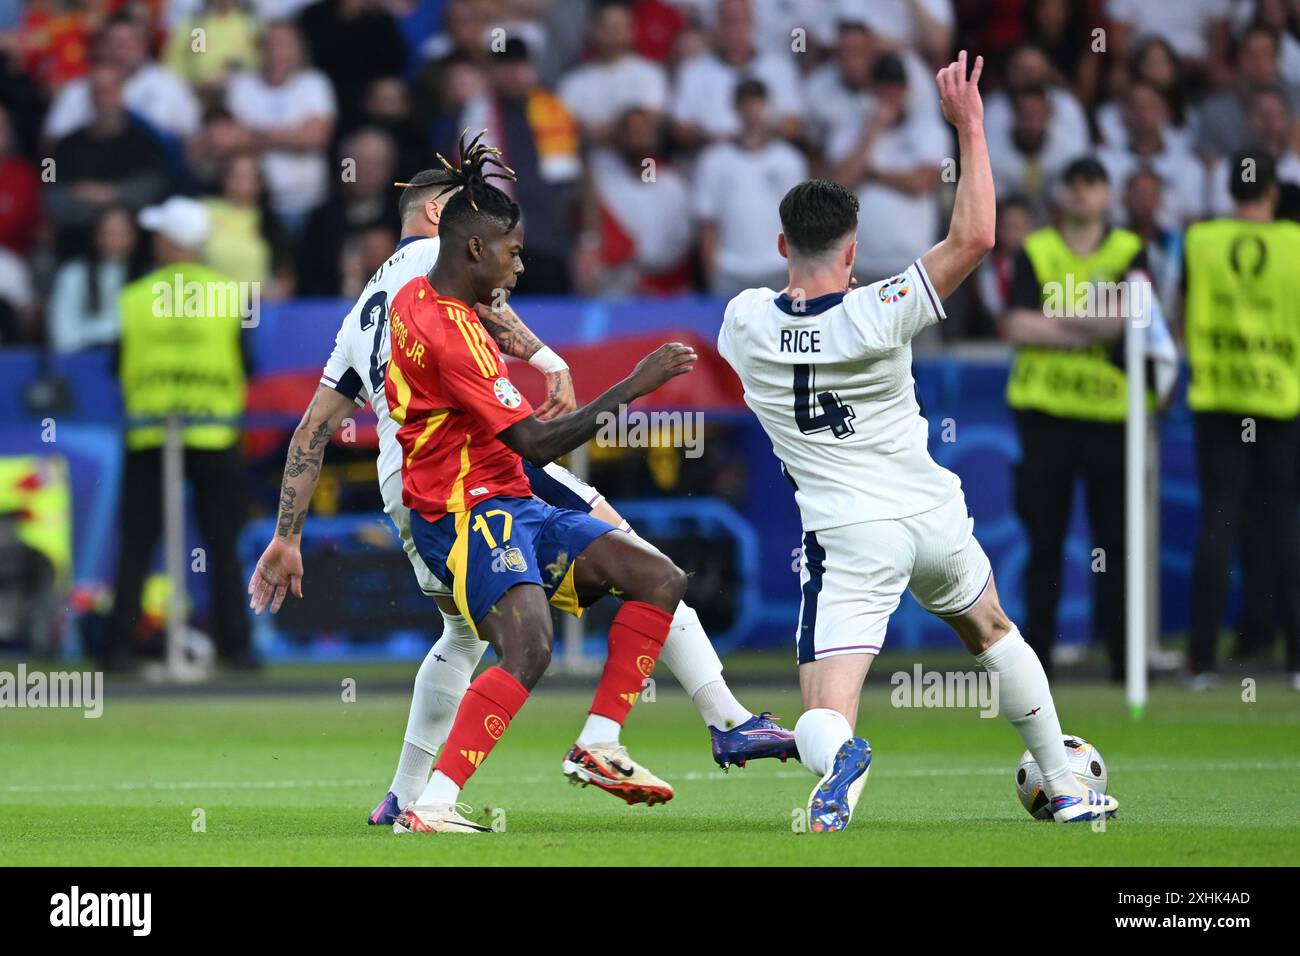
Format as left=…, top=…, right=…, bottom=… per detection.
left=411, top=498, right=616, bottom=624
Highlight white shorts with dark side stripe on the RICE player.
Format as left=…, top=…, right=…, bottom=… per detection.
left=796, top=494, right=993, bottom=663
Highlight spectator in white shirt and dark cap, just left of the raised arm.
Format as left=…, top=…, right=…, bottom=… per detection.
left=826, top=53, right=952, bottom=282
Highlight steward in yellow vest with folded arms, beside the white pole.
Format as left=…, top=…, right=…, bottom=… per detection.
left=1000, top=157, right=1149, bottom=680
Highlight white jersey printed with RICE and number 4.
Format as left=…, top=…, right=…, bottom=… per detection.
left=718, top=260, right=961, bottom=532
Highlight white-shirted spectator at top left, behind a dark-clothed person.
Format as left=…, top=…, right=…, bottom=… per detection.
left=42, top=13, right=199, bottom=140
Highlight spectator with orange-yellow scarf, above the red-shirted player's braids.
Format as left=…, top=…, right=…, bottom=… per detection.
left=457, top=36, right=579, bottom=294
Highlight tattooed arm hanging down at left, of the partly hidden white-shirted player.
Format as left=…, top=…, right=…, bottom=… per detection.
left=248, top=385, right=356, bottom=614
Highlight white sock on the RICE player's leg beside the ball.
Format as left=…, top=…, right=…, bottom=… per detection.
left=975, top=626, right=1083, bottom=796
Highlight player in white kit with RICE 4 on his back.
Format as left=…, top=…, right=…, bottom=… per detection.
left=718, top=51, right=1118, bottom=832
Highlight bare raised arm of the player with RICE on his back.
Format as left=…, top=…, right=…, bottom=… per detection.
left=920, top=49, right=997, bottom=299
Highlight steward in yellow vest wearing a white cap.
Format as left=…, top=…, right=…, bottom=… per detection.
left=105, top=196, right=260, bottom=667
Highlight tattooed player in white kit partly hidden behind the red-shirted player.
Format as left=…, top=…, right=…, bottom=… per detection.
left=248, top=170, right=798, bottom=826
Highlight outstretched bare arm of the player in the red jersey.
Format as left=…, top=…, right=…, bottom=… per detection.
left=497, top=342, right=697, bottom=466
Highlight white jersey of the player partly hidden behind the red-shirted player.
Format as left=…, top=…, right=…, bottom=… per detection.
left=321, top=237, right=439, bottom=489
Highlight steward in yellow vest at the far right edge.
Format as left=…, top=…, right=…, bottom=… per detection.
left=1183, top=152, right=1300, bottom=689
